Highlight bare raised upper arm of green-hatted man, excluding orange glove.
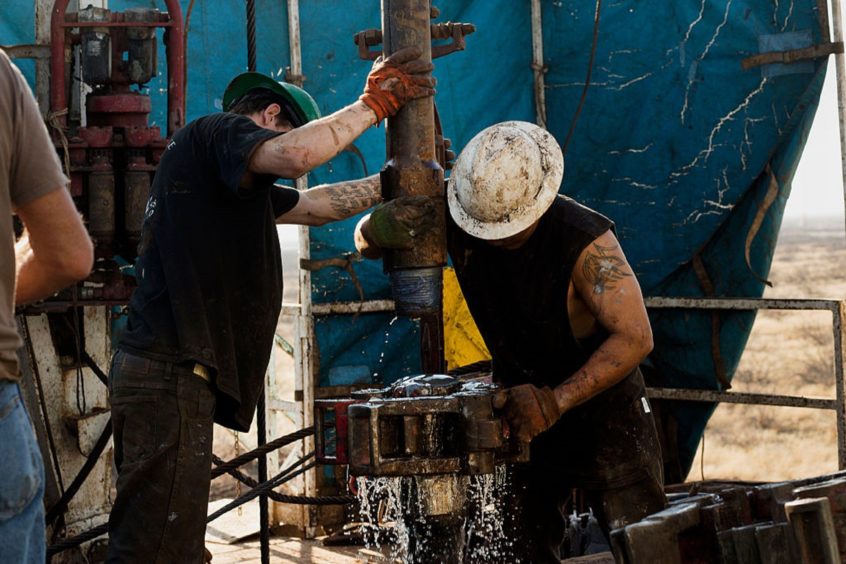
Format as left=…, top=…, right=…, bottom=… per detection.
left=249, top=100, right=376, bottom=178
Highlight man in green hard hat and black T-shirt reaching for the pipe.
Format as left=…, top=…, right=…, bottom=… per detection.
left=108, top=49, right=434, bottom=564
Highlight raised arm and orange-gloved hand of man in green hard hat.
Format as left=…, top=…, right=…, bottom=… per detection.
left=249, top=47, right=435, bottom=178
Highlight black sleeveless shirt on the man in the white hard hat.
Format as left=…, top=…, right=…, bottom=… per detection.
left=447, top=196, right=660, bottom=488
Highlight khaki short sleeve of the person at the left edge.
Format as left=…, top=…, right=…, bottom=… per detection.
left=0, top=54, right=68, bottom=208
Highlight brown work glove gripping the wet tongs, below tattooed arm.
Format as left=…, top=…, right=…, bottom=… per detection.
left=494, top=384, right=561, bottom=443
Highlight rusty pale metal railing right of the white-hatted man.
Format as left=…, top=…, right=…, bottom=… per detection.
left=645, top=297, right=846, bottom=470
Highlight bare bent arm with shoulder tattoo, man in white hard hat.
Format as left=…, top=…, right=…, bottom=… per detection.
left=554, top=231, right=652, bottom=413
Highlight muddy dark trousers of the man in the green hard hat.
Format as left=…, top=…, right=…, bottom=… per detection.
left=107, top=351, right=215, bottom=564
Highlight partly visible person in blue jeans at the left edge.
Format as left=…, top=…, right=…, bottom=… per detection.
left=0, top=50, right=94, bottom=564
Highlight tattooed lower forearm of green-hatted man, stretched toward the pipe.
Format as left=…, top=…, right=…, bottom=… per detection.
left=276, top=174, right=382, bottom=225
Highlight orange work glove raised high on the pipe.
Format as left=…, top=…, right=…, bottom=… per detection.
left=359, top=47, right=435, bottom=124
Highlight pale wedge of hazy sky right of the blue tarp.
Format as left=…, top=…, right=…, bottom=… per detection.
left=784, top=49, right=844, bottom=218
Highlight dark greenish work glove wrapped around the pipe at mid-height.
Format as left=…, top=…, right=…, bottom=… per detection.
left=362, top=196, right=435, bottom=249
